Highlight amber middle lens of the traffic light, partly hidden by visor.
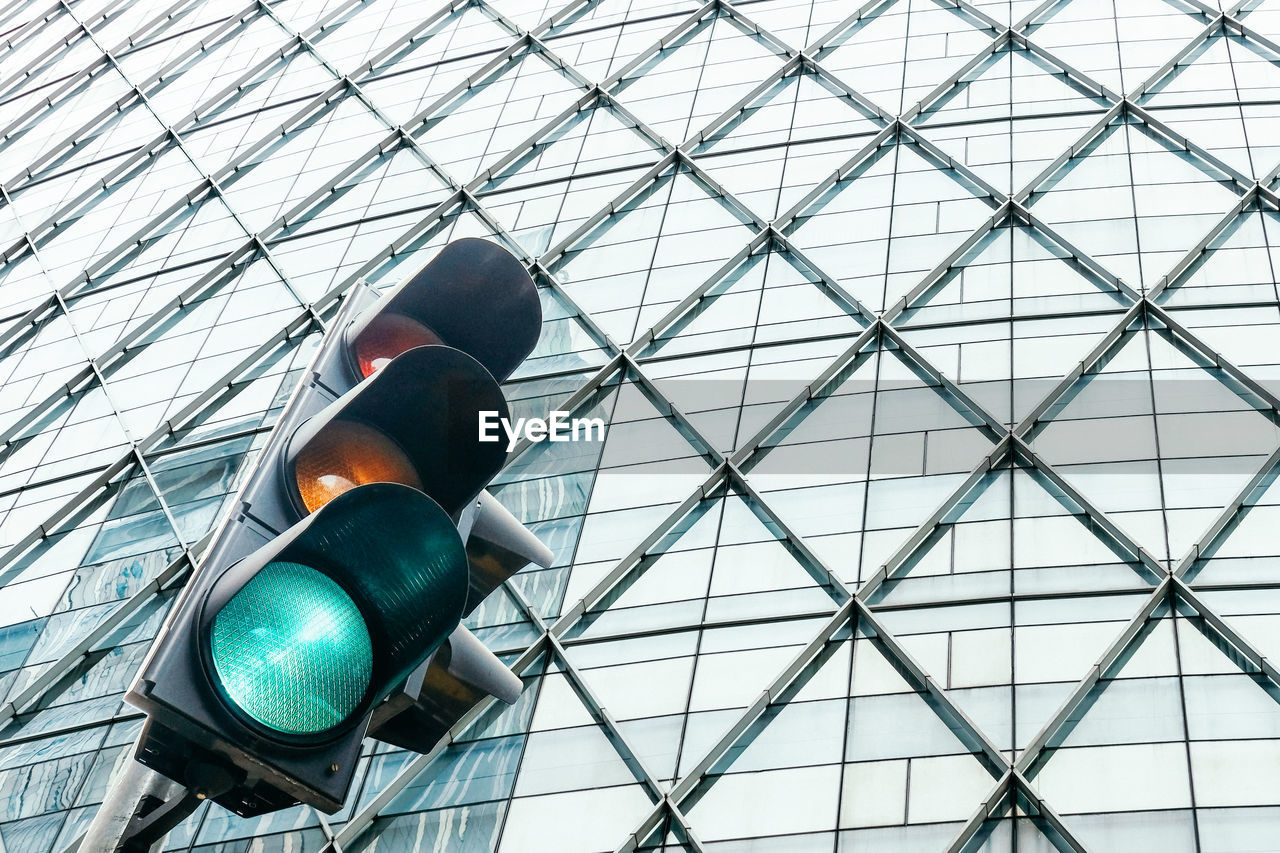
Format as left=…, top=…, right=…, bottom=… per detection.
left=293, top=420, right=422, bottom=512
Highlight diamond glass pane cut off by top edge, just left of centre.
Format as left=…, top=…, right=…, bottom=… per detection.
left=541, top=0, right=698, bottom=83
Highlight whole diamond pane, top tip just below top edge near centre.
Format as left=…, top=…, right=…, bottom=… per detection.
left=613, top=12, right=783, bottom=145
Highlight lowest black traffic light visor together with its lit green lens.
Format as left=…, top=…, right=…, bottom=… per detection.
left=198, top=483, right=468, bottom=743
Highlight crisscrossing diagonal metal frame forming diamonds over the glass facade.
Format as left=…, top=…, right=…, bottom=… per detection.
left=0, top=0, right=1280, bottom=853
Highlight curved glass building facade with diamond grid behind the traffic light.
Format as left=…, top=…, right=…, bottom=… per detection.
left=0, top=0, right=1280, bottom=853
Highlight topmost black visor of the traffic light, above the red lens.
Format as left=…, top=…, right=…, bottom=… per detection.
left=347, top=237, right=543, bottom=382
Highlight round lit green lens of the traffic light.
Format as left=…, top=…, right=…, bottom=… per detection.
left=210, top=561, right=374, bottom=735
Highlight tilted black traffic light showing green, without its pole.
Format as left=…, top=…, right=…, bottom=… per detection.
left=120, top=240, right=550, bottom=816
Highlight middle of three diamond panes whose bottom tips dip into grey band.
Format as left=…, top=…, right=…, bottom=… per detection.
left=895, top=216, right=1132, bottom=424
